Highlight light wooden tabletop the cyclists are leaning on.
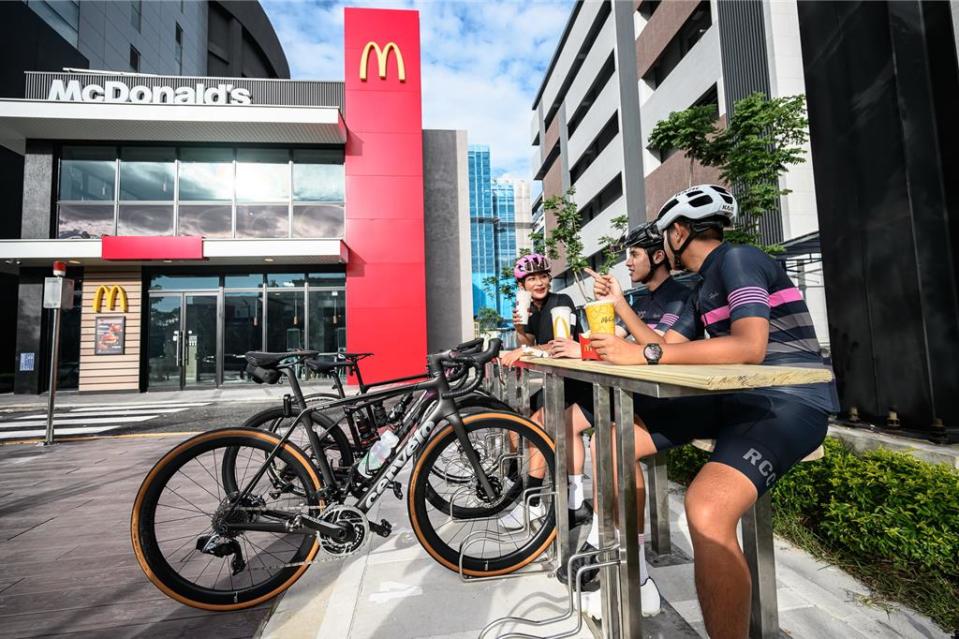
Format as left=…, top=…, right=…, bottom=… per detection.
left=520, top=357, right=833, bottom=391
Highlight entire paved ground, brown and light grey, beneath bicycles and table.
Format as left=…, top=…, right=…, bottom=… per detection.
left=0, top=435, right=948, bottom=639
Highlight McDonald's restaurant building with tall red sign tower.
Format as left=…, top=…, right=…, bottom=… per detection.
left=0, top=9, right=472, bottom=393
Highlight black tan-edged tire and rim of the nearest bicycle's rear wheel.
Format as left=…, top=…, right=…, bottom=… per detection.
left=130, top=428, right=322, bottom=611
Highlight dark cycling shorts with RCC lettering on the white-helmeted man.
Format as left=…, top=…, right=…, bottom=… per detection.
left=633, top=393, right=828, bottom=495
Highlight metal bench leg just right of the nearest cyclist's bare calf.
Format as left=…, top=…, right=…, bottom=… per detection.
left=742, top=492, right=779, bottom=639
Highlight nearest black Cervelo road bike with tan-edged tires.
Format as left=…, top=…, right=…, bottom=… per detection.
left=131, top=340, right=556, bottom=611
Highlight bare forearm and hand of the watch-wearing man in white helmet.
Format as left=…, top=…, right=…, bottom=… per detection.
left=590, top=317, right=769, bottom=364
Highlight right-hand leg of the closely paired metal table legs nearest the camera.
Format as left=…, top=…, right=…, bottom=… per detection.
left=614, top=388, right=643, bottom=637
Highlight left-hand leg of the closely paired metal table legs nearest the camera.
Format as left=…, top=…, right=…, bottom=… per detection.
left=593, top=384, right=624, bottom=639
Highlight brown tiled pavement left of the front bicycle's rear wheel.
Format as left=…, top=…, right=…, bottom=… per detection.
left=0, top=435, right=269, bottom=639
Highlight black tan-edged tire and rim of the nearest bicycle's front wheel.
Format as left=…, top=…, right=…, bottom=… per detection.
left=407, top=413, right=556, bottom=577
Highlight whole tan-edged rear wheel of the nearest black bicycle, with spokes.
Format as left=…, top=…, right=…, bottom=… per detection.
left=130, top=428, right=323, bottom=611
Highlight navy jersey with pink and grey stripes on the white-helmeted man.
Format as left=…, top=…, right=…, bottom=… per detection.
left=672, top=243, right=838, bottom=412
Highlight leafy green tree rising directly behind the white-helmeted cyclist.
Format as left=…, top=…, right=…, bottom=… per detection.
left=649, top=93, right=809, bottom=253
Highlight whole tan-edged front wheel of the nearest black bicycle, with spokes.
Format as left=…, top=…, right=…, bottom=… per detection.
left=407, top=413, right=556, bottom=577
